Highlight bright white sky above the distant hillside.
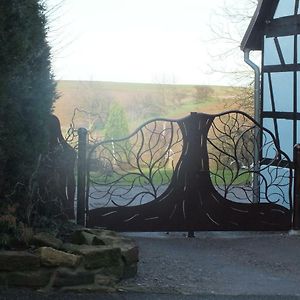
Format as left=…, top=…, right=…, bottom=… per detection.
left=46, top=0, right=255, bottom=85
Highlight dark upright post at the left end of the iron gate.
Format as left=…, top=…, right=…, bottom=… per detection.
left=77, top=128, right=87, bottom=226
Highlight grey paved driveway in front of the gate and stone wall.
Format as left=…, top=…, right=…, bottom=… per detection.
left=0, top=232, right=300, bottom=300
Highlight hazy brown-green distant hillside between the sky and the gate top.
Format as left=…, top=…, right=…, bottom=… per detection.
left=54, top=81, right=243, bottom=135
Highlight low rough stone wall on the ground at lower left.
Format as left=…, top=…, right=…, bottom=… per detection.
left=0, top=229, right=138, bottom=291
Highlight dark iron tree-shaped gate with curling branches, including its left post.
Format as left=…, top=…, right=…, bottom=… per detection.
left=77, top=111, right=292, bottom=231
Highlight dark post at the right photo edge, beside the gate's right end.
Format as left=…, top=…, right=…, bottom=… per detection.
left=293, top=144, right=300, bottom=230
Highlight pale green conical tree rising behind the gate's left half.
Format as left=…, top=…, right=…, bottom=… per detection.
left=105, top=103, right=129, bottom=140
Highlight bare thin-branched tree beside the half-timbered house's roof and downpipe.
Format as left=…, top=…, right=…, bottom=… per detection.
left=210, top=0, right=258, bottom=113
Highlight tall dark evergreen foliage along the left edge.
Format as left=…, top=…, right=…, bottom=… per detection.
left=0, top=0, right=56, bottom=218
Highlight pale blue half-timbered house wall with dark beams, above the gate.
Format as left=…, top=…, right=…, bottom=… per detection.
left=261, top=0, right=300, bottom=158
